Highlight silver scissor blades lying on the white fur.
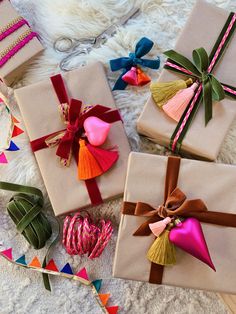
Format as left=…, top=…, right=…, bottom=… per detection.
left=93, top=8, right=140, bottom=48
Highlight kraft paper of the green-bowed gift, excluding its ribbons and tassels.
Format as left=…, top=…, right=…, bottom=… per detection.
left=137, top=0, right=236, bottom=160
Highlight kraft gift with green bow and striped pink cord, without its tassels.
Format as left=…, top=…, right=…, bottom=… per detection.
left=137, top=0, right=236, bottom=160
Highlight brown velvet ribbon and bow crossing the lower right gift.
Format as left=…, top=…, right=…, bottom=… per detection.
left=122, top=156, right=236, bottom=284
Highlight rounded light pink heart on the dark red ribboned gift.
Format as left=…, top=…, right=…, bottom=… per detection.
left=84, top=117, right=111, bottom=146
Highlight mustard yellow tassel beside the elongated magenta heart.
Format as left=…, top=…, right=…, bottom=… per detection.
left=147, top=229, right=176, bottom=266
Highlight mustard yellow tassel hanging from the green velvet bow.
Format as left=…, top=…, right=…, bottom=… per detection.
left=150, top=78, right=193, bottom=108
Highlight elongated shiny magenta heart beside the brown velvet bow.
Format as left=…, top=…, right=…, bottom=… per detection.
left=169, top=218, right=216, bottom=271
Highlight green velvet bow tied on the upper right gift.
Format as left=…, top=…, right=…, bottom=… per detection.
left=164, top=48, right=225, bottom=125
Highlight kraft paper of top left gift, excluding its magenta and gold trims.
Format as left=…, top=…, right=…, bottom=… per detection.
left=0, top=0, right=44, bottom=86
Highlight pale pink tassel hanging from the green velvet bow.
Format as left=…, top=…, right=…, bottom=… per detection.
left=162, top=83, right=198, bottom=122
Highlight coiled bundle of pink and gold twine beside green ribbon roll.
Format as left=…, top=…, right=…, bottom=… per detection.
left=62, top=213, right=113, bottom=259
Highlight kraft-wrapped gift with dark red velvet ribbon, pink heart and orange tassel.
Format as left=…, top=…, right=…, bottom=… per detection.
left=15, top=63, right=130, bottom=215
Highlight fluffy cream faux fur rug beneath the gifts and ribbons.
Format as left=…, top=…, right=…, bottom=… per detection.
left=0, top=0, right=236, bottom=314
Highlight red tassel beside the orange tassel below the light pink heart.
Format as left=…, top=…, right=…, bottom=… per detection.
left=86, top=144, right=119, bottom=173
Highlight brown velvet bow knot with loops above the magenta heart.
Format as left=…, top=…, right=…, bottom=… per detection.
left=133, top=188, right=207, bottom=236
